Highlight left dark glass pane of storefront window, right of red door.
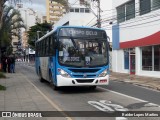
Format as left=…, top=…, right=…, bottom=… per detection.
left=142, top=46, right=153, bottom=71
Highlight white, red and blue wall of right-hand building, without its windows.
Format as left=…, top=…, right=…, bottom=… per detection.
left=112, top=0, right=160, bottom=78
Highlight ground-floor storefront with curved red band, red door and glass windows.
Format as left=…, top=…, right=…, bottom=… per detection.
left=112, top=32, right=160, bottom=78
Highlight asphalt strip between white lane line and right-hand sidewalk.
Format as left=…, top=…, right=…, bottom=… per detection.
left=103, top=81, right=160, bottom=105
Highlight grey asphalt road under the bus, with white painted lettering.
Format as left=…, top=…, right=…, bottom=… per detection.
left=16, top=63, right=160, bottom=120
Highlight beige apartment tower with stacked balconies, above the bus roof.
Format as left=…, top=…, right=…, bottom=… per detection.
left=46, top=0, right=65, bottom=24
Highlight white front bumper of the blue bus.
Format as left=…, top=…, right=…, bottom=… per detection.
left=57, top=75, right=109, bottom=86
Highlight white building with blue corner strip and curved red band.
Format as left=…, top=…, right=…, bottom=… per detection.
left=112, top=0, right=160, bottom=78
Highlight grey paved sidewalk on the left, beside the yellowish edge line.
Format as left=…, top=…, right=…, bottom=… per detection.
left=0, top=73, right=65, bottom=120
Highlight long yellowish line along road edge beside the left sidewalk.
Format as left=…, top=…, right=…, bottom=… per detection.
left=22, top=75, right=73, bottom=120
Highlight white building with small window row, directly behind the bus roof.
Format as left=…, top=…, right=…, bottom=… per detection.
left=54, top=0, right=112, bottom=30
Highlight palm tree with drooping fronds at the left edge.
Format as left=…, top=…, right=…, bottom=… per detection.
left=0, top=7, right=25, bottom=55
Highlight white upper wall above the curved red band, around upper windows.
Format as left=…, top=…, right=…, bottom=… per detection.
left=113, top=0, right=160, bottom=46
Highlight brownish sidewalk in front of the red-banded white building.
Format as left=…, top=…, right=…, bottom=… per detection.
left=110, top=72, right=160, bottom=91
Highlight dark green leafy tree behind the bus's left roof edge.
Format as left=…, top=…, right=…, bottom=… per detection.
left=27, top=22, right=52, bottom=49
